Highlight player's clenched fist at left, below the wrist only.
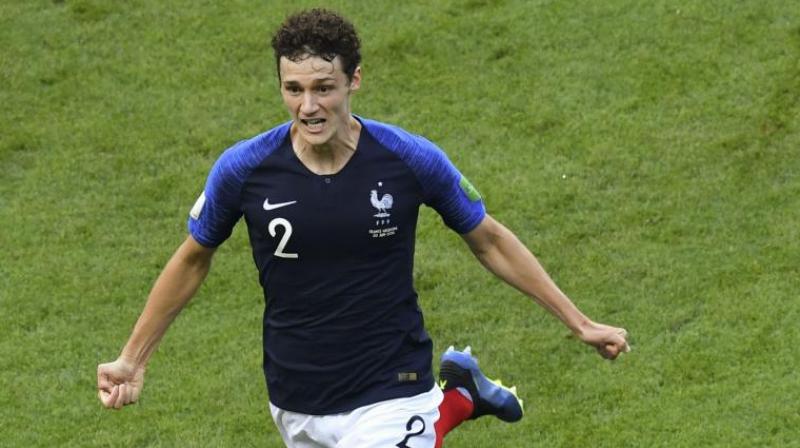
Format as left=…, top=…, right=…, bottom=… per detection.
left=97, top=358, right=144, bottom=409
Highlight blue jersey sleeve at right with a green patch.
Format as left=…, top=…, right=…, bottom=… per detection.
left=415, top=137, right=486, bottom=234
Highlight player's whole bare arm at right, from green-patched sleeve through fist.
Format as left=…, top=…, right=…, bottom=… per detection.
left=462, top=215, right=628, bottom=359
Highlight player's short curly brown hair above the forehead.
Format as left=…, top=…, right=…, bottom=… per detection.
left=272, top=9, right=361, bottom=80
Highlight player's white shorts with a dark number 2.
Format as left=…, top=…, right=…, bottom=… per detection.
left=269, top=386, right=443, bottom=448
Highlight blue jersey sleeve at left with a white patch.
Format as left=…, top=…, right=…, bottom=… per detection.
left=188, top=143, right=244, bottom=247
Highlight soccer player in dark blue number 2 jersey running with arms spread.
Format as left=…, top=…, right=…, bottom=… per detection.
left=97, top=10, right=627, bottom=448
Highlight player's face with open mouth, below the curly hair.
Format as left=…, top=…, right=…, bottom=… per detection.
left=280, top=56, right=361, bottom=146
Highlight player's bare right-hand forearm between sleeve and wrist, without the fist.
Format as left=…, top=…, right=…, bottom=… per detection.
left=468, top=221, right=590, bottom=334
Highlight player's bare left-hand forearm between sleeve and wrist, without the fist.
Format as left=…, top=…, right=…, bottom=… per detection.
left=120, top=239, right=211, bottom=366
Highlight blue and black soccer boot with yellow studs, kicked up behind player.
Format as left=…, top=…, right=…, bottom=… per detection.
left=439, top=346, right=523, bottom=422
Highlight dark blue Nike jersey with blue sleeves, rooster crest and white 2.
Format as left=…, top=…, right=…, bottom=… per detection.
left=189, top=118, right=485, bottom=415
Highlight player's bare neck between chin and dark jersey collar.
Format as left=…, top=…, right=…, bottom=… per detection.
left=291, top=117, right=361, bottom=175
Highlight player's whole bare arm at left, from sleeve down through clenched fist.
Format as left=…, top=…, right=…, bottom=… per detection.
left=97, top=236, right=214, bottom=409
